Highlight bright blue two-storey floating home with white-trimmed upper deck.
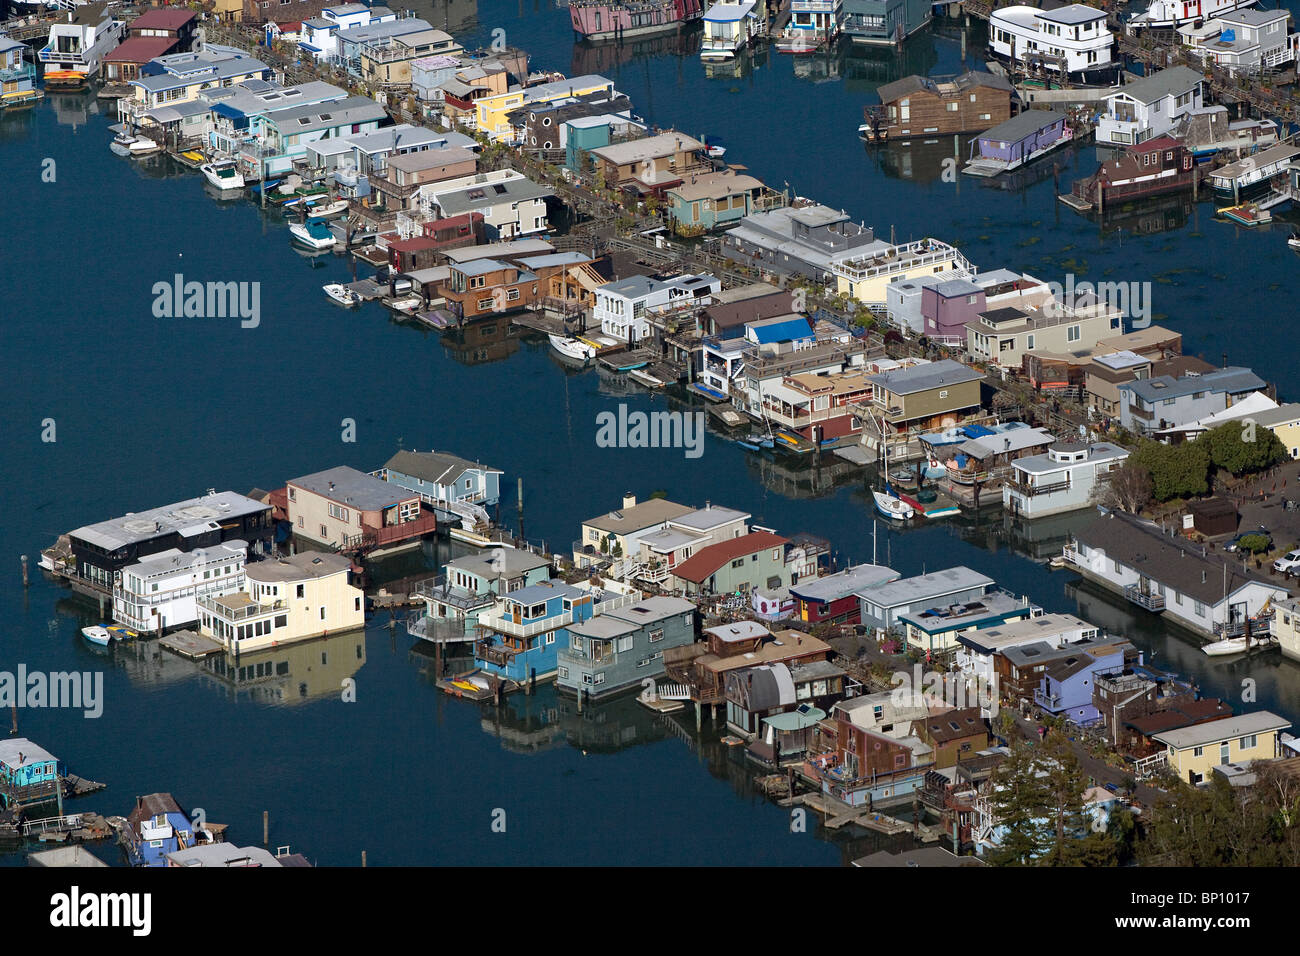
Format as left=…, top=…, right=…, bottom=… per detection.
left=475, top=579, right=641, bottom=683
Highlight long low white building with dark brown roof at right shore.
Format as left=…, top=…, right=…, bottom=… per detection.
left=1065, top=511, right=1287, bottom=640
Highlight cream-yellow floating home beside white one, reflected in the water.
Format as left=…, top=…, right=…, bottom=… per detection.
left=199, top=551, right=365, bottom=653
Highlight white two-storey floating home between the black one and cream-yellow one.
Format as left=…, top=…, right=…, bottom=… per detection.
left=113, top=540, right=248, bottom=633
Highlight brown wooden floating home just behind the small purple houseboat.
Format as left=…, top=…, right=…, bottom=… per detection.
left=862, top=72, right=1014, bottom=143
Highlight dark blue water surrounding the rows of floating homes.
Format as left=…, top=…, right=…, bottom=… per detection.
left=0, top=3, right=1300, bottom=865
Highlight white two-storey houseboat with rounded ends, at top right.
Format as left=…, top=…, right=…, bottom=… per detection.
left=988, top=4, right=1119, bottom=86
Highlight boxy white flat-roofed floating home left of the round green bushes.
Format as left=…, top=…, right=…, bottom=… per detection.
left=1002, top=441, right=1128, bottom=518
